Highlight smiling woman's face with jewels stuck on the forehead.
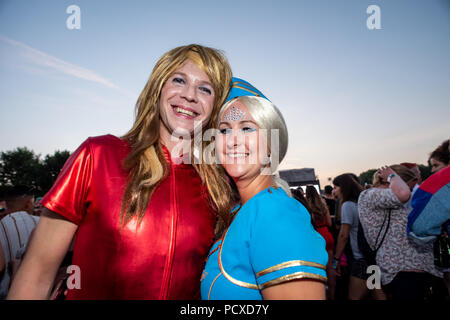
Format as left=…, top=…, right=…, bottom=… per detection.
left=216, top=101, right=267, bottom=181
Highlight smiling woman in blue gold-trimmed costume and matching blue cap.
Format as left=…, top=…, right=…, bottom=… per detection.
left=201, top=78, right=328, bottom=300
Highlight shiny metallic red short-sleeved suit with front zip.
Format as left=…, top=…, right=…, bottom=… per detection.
left=42, top=135, right=215, bottom=299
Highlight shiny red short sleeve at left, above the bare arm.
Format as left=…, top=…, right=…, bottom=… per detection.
left=41, top=139, right=92, bottom=224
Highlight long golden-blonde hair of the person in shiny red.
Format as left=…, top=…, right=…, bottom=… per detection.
left=120, top=44, right=232, bottom=226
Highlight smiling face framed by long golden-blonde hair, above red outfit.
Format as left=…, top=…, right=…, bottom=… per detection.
left=159, top=60, right=215, bottom=145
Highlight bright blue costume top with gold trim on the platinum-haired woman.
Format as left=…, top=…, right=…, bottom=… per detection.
left=201, top=187, right=328, bottom=300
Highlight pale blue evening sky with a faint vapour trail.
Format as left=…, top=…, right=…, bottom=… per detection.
left=0, top=0, right=450, bottom=187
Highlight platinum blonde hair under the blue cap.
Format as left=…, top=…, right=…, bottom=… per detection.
left=219, top=96, right=288, bottom=169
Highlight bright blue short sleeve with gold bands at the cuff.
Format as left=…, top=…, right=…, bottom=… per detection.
left=249, top=198, right=328, bottom=289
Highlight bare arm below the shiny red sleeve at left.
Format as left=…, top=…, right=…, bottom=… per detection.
left=7, top=208, right=78, bottom=300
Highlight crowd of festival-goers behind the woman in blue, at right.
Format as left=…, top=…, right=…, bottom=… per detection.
left=293, top=140, right=450, bottom=300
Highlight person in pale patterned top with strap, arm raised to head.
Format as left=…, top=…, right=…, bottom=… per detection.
left=358, top=165, right=442, bottom=300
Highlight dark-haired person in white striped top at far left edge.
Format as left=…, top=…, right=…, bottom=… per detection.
left=0, top=186, right=39, bottom=300
